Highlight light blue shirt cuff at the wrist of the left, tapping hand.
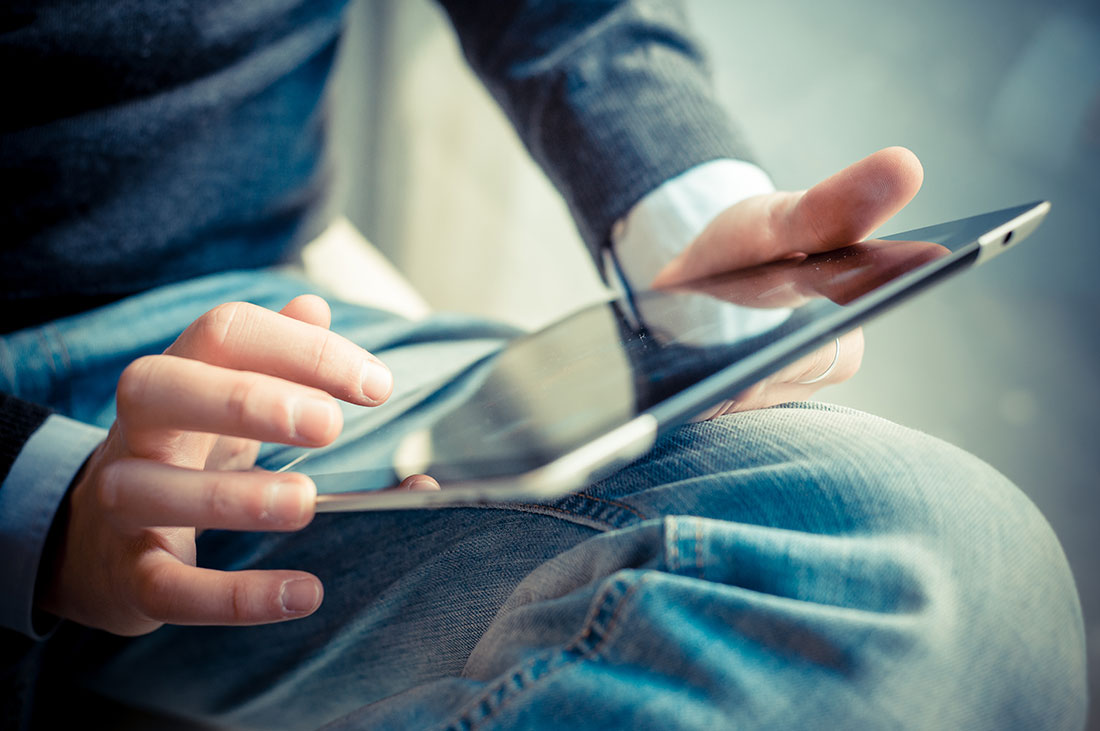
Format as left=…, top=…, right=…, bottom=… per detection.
left=0, top=413, right=107, bottom=639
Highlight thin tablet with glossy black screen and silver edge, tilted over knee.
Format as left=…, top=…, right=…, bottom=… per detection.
left=299, top=201, right=1049, bottom=512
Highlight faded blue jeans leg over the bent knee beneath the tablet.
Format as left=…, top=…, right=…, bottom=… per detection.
left=321, top=403, right=1086, bottom=729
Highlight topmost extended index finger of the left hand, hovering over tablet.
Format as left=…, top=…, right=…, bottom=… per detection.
left=165, top=302, right=394, bottom=406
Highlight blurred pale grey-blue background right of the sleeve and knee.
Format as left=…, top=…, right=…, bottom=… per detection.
left=690, top=7, right=1100, bottom=729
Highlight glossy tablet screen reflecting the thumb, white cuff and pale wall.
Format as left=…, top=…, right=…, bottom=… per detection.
left=294, top=202, right=1038, bottom=491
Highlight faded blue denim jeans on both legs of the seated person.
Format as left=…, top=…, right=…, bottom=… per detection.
left=8, top=272, right=1086, bottom=729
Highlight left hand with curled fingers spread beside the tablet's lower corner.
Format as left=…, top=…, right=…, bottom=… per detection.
left=39, top=295, right=393, bottom=635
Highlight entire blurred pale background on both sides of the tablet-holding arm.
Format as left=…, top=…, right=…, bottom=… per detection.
left=332, top=0, right=1100, bottom=730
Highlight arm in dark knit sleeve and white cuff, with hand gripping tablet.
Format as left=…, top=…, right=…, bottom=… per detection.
left=440, top=0, right=921, bottom=410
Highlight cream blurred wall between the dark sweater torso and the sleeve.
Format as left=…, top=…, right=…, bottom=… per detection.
left=333, top=0, right=604, bottom=328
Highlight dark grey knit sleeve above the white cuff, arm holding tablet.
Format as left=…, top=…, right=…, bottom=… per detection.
left=440, top=0, right=747, bottom=252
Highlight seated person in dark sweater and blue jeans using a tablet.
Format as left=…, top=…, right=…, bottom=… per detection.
left=0, top=0, right=1085, bottom=729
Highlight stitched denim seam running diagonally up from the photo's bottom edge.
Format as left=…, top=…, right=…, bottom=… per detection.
left=441, top=576, right=649, bottom=731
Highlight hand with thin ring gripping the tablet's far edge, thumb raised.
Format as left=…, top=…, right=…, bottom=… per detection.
left=652, top=147, right=924, bottom=418
